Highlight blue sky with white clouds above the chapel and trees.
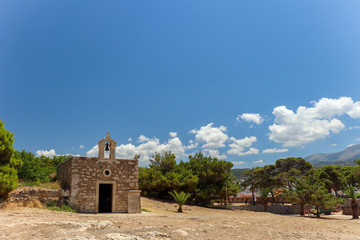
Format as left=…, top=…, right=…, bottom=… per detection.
left=0, top=0, right=360, bottom=168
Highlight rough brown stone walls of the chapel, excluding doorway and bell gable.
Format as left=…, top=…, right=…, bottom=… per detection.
left=70, top=157, right=138, bottom=212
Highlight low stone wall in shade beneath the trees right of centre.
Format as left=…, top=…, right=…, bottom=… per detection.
left=232, top=204, right=307, bottom=214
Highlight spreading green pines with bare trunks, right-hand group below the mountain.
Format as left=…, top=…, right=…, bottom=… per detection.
left=241, top=157, right=360, bottom=218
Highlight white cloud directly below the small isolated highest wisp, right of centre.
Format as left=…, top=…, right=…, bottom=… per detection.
left=227, top=136, right=259, bottom=156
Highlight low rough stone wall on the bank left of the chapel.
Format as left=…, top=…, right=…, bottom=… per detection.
left=6, top=187, right=59, bottom=204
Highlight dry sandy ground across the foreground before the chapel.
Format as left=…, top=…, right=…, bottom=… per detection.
left=0, top=198, right=360, bottom=240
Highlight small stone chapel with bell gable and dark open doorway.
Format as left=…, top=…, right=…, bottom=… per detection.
left=58, top=133, right=141, bottom=213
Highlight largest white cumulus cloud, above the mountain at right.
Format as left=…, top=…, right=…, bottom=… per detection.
left=269, top=97, right=360, bottom=146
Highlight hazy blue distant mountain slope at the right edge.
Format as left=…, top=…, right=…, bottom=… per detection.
left=305, top=144, right=360, bottom=168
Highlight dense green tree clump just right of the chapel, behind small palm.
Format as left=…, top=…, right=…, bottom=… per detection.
left=139, top=151, right=240, bottom=206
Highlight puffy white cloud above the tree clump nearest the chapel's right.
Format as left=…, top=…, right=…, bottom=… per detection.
left=190, top=123, right=229, bottom=148
